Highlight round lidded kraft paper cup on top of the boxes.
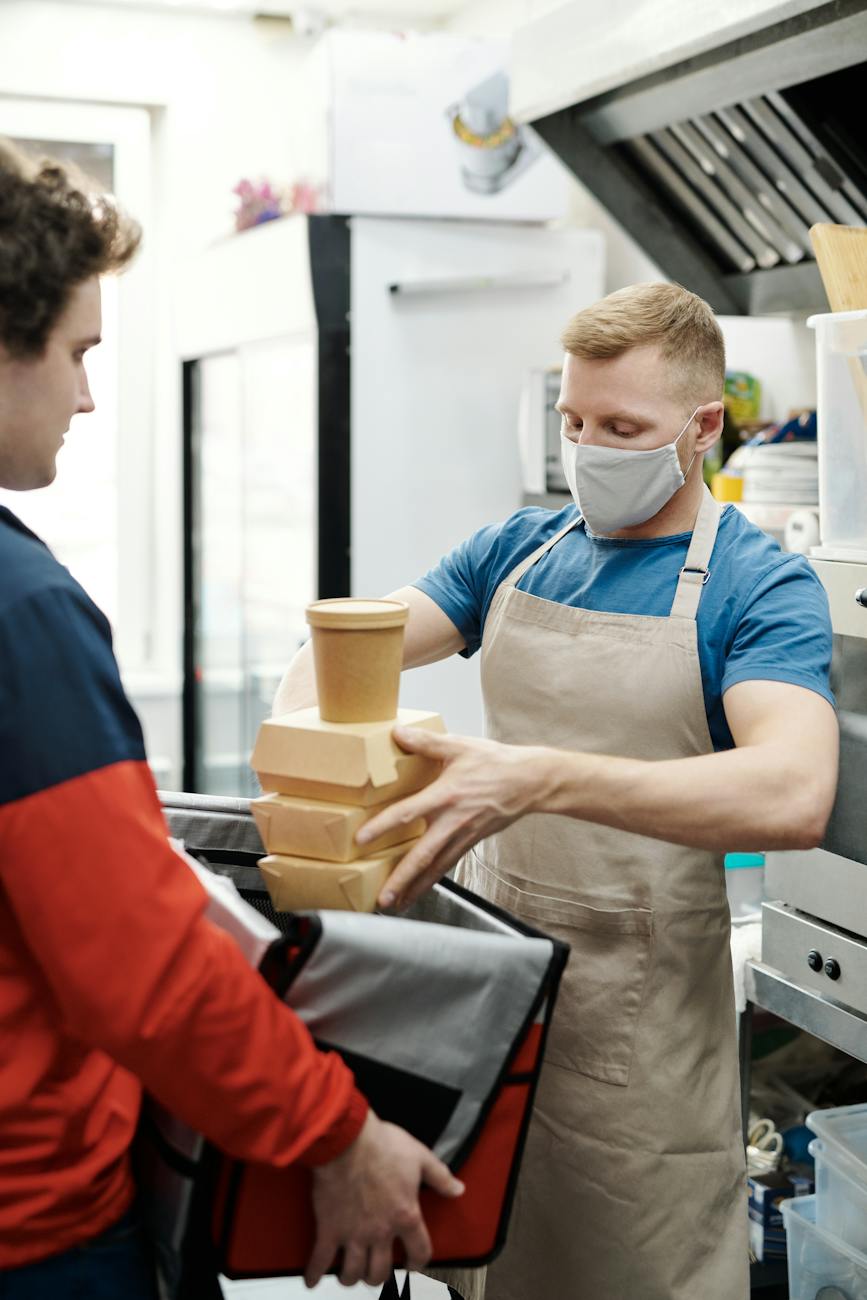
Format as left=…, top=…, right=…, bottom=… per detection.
left=307, top=597, right=409, bottom=723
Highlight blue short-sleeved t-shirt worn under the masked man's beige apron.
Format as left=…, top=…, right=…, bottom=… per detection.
left=415, top=504, right=835, bottom=750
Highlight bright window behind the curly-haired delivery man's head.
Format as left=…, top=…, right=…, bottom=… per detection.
left=0, top=96, right=153, bottom=671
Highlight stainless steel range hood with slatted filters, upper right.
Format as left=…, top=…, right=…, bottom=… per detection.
left=516, top=0, right=867, bottom=315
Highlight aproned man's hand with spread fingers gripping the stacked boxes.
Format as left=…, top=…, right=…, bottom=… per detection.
left=356, top=727, right=551, bottom=907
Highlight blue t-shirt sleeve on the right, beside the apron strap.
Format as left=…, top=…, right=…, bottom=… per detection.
left=721, top=555, right=835, bottom=705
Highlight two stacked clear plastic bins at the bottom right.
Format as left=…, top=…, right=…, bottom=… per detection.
left=783, top=1104, right=867, bottom=1300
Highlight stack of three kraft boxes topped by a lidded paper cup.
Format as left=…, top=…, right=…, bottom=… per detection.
left=251, top=598, right=445, bottom=911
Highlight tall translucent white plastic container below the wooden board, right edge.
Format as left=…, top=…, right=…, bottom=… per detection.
left=807, top=311, right=867, bottom=562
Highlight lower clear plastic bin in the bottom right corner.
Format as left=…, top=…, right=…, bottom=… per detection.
left=783, top=1196, right=867, bottom=1300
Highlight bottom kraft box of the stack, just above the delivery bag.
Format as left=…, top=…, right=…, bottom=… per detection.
left=259, top=841, right=413, bottom=911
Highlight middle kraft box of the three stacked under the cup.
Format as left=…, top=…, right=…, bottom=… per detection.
left=250, top=794, right=425, bottom=862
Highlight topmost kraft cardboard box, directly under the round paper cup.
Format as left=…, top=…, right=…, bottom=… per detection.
left=251, top=709, right=446, bottom=807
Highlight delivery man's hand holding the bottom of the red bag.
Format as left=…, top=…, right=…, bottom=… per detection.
left=304, top=1110, right=464, bottom=1287
